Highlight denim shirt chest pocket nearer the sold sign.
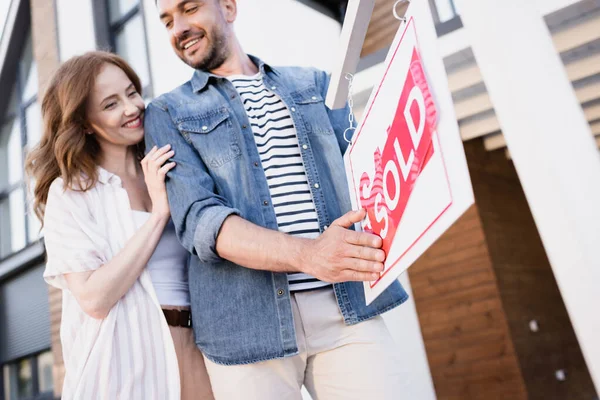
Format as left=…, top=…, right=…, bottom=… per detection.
left=291, top=86, right=334, bottom=135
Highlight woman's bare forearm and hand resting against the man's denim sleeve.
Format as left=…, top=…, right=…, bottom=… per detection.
left=65, top=146, right=175, bottom=319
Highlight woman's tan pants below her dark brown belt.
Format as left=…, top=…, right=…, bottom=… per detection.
left=163, top=306, right=214, bottom=400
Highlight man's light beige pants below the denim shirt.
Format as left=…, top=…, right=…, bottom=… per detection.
left=205, top=289, right=403, bottom=400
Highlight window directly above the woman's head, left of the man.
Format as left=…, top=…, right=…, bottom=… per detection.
left=101, top=0, right=152, bottom=97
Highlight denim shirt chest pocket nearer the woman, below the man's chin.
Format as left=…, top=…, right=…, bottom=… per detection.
left=177, top=108, right=242, bottom=168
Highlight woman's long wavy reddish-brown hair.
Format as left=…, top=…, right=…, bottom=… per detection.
left=25, top=51, right=144, bottom=224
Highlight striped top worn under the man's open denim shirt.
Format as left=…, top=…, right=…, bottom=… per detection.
left=228, top=73, right=330, bottom=292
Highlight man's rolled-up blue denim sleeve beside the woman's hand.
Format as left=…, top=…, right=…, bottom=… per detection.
left=144, top=102, right=240, bottom=263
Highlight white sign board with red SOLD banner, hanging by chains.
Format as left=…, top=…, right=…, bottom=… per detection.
left=344, top=14, right=474, bottom=305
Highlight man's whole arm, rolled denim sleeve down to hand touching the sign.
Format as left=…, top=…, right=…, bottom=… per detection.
left=145, top=103, right=385, bottom=282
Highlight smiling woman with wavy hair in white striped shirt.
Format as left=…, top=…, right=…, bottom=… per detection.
left=27, top=52, right=213, bottom=400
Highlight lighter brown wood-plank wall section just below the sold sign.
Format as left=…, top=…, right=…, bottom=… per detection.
left=409, top=205, right=527, bottom=400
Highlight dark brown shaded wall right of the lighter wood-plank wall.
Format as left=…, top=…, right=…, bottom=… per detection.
left=465, top=140, right=595, bottom=400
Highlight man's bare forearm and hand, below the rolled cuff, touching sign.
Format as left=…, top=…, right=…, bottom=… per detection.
left=217, top=210, right=385, bottom=282
